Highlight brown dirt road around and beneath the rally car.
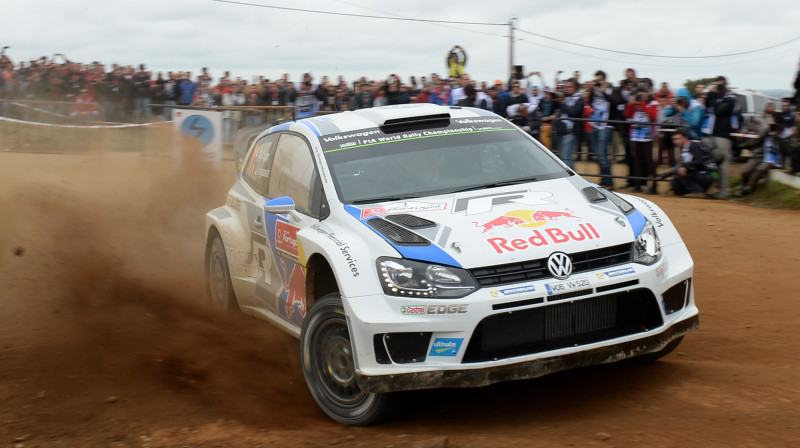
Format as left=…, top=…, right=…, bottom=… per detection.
left=0, top=153, right=800, bottom=448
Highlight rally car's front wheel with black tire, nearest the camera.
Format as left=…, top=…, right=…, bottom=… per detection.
left=300, top=294, right=400, bottom=426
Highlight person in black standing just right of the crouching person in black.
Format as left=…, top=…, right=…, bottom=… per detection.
left=704, top=76, right=739, bottom=199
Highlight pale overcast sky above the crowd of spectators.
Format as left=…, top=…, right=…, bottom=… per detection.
left=6, top=0, right=800, bottom=90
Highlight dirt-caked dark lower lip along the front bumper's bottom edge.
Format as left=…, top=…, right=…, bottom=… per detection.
left=357, top=315, right=700, bottom=393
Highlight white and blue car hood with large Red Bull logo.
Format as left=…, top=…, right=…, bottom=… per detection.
left=345, top=179, right=646, bottom=268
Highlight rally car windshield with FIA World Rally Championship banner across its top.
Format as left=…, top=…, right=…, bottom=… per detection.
left=320, top=117, right=571, bottom=204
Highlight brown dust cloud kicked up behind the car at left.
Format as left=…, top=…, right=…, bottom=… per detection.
left=0, top=129, right=322, bottom=435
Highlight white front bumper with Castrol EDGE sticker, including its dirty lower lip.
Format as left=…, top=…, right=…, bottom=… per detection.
left=344, top=244, right=699, bottom=392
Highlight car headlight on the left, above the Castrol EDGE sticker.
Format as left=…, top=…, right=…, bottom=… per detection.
left=378, top=258, right=479, bottom=299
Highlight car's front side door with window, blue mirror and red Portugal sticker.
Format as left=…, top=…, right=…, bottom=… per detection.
left=262, top=132, right=322, bottom=326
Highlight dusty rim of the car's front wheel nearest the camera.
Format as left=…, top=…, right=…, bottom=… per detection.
left=312, top=318, right=371, bottom=408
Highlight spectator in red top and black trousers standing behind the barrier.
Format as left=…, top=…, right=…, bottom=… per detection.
left=625, top=87, right=658, bottom=193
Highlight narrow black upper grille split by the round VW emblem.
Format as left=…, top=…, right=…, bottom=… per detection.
left=469, top=243, right=633, bottom=286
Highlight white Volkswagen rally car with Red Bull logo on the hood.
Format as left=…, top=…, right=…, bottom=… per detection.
left=205, top=104, right=699, bottom=425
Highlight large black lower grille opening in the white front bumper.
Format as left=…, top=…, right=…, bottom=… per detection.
left=463, top=289, right=664, bottom=363
